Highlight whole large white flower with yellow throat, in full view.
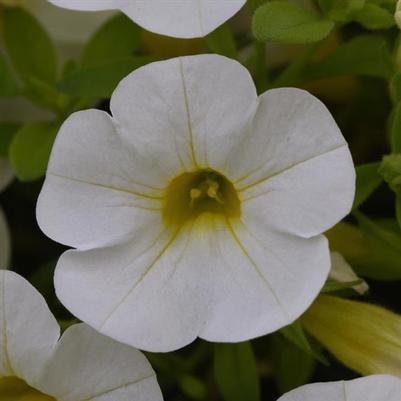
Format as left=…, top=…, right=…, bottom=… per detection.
left=37, top=55, right=355, bottom=351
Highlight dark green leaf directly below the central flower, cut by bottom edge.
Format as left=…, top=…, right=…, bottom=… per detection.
left=213, top=341, right=260, bottom=401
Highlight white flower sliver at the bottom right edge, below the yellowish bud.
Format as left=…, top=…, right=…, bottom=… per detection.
left=278, top=375, right=401, bottom=401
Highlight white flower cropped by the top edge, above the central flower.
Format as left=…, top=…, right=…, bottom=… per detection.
left=49, top=0, right=246, bottom=38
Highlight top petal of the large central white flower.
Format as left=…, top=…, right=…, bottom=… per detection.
left=110, top=55, right=258, bottom=172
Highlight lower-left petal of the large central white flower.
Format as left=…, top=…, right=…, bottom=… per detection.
left=55, top=222, right=208, bottom=352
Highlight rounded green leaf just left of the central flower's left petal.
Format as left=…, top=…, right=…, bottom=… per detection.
left=10, top=122, right=58, bottom=181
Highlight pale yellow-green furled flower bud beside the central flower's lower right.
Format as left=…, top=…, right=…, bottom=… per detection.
left=302, top=295, right=401, bottom=377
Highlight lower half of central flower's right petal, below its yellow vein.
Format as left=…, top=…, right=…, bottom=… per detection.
left=240, top=146, right=355, bottom=238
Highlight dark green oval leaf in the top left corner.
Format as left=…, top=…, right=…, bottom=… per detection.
left=3, top=7, right=57, bottom=82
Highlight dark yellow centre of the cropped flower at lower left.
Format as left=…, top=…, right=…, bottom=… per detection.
left=0, top=377, right=56, bottom=401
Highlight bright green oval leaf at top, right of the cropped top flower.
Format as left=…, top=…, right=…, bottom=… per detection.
left=252, top=1, right=334, bottom=43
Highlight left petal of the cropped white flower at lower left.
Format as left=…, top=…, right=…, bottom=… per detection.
left=0, top=271, right=60, bottom=386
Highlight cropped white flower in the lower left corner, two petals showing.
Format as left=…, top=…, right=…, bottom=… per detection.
left=0, top=271, right=162, bottom=401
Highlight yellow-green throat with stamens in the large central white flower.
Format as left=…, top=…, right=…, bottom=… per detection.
left=163, top=169, right=241, bottom=225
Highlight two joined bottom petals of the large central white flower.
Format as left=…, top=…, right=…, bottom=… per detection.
left=55, top=215, right=329, bottom=351
